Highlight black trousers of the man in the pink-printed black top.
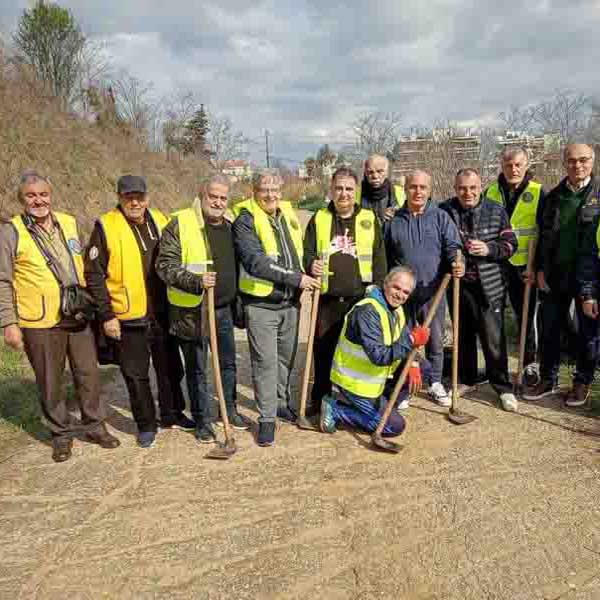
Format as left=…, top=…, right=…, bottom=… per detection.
left=306, top=295, right=360, bottom=415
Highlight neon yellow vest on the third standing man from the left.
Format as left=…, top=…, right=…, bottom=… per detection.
left=167, top=208, right=213, bottom=308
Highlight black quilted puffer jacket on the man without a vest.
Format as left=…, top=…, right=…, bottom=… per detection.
left=440, top=197, right=517, bottom=307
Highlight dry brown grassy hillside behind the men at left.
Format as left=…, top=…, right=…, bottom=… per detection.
left=0, top=55, right=214, bottom=233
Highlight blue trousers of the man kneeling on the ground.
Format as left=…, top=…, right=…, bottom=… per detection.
left=332, top=361, right=431, bottom=437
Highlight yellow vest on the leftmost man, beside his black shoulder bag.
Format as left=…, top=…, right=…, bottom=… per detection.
left=11, top=212, right=85, bottom=329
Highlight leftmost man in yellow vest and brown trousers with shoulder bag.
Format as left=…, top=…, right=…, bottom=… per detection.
left=0, top=171, right=119, bottom=462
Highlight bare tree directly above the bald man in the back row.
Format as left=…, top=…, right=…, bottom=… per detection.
left=352, top=111, right=402, bottom=158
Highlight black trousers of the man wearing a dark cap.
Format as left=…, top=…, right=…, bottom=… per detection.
left=118, top=321, right=185, bottom=431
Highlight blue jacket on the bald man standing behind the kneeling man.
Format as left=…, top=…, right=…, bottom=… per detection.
left=384, top=200, right=462, bottom=306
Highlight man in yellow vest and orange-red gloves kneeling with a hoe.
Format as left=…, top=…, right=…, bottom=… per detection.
left=320, top=266, right=430, bottom=436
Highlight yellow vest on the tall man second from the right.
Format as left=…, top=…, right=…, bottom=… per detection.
left=485, top=181, right=542, bottom=267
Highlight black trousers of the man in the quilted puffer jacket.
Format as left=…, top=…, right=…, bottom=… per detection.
left=448, top=281, right=510, bottom=393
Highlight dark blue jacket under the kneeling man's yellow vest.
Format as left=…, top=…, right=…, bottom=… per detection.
left=346, top=287, right=413, bottom=366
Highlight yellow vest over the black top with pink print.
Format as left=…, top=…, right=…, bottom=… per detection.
left=315, top=208, right=375, bottom=294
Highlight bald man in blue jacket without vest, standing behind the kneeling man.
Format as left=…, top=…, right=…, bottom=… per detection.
left=384, top=171, right=464, bottom=406
